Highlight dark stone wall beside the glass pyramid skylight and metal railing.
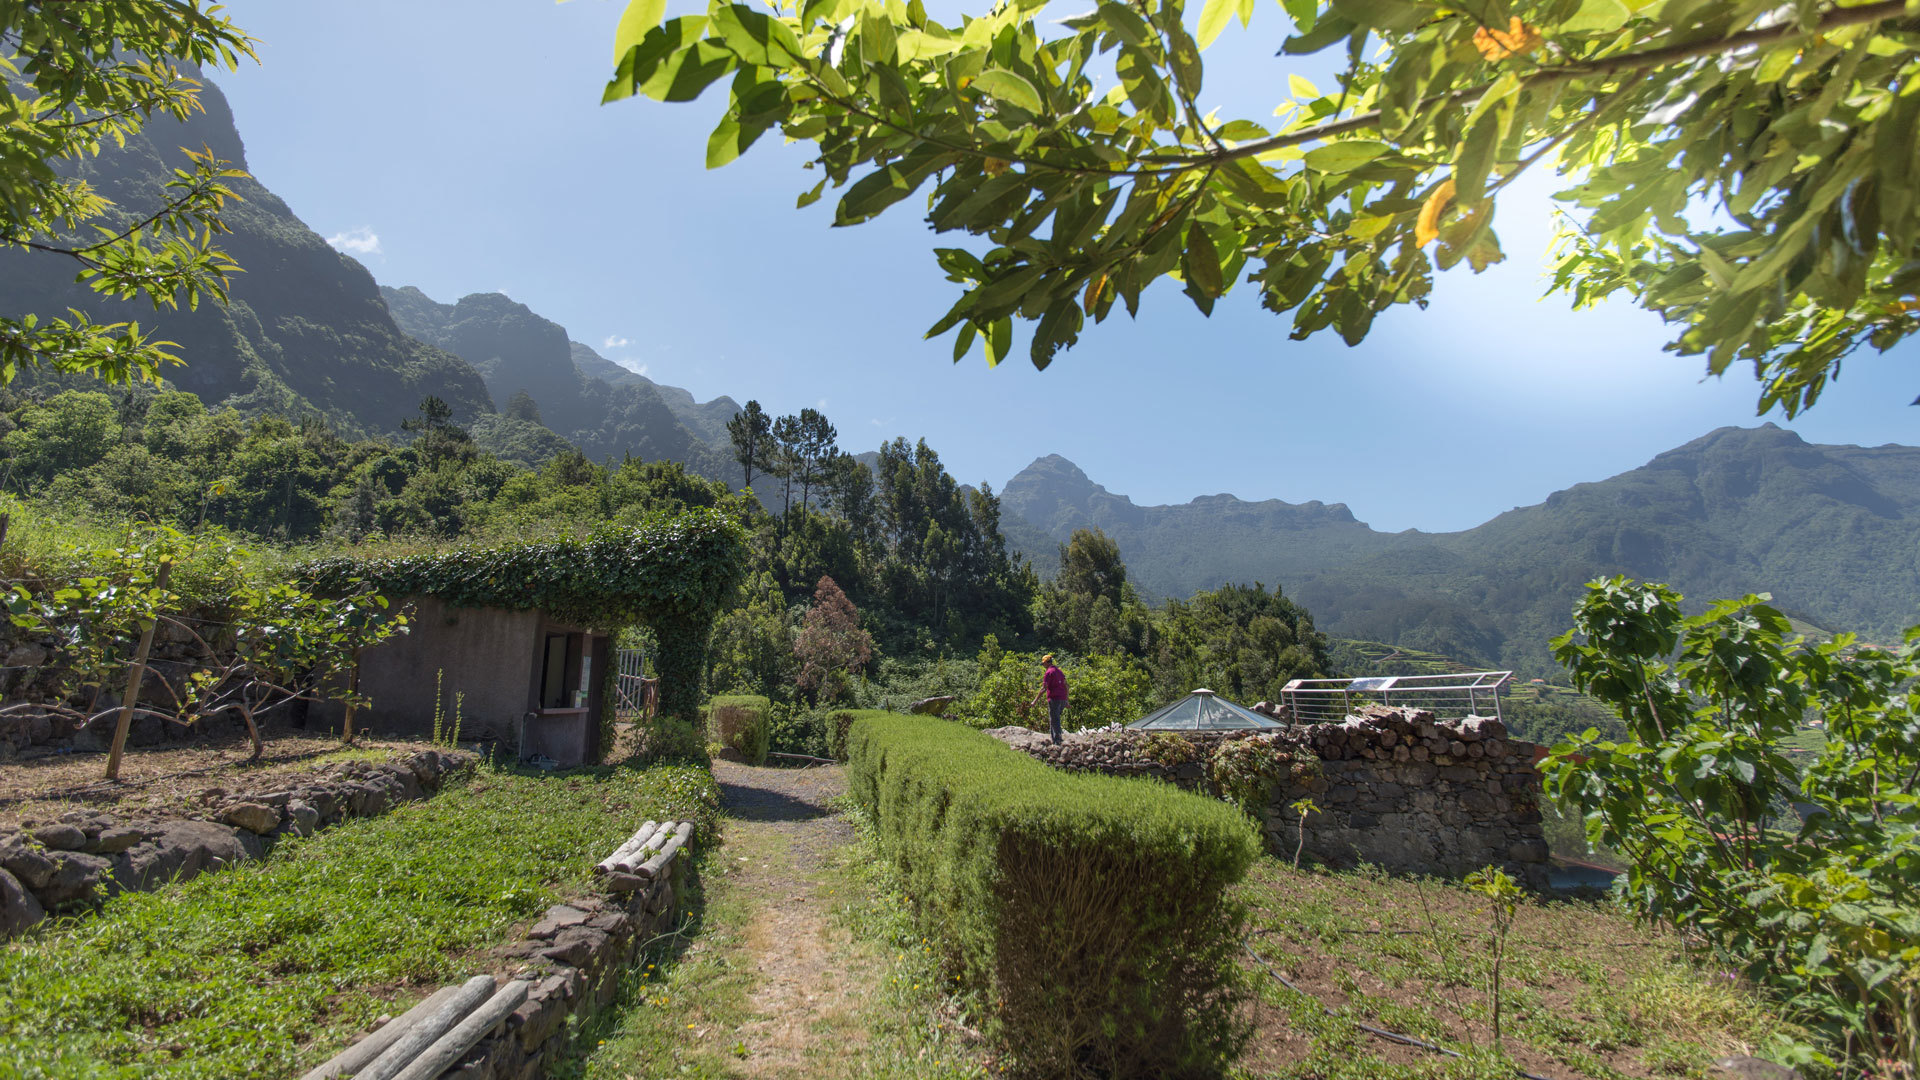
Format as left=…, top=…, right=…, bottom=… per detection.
left=987, top=705, right=1548, bottom=888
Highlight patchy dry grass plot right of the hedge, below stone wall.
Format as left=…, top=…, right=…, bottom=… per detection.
left=1236, top=859, right=1793, bottom=1080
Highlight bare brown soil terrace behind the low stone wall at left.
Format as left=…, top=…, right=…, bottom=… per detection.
left=0, top=732, right=426, bottom=830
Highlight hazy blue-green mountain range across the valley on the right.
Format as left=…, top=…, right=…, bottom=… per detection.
left=1002, top=425, right=1920, bottom=671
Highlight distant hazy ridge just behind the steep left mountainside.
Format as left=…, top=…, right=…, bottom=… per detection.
left=382, top=286, right=733, bottom=480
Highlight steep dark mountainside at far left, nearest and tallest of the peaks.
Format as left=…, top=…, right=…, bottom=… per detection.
left=0, top=70, right=492, bottom=430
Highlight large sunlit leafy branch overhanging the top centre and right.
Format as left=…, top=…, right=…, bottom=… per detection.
left=605, top=0, right=1920, bottom=415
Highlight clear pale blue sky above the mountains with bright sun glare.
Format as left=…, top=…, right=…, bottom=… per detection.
left=202, top=0, right=1920, bottom=530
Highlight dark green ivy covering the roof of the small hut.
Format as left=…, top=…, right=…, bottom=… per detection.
left=300, top=507, right=747, bottom=626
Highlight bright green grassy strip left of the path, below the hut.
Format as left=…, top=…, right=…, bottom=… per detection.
left=0, top=767, right=718, bottom=1080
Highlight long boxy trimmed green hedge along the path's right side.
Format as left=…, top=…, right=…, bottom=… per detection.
left=847, top=715, right=1260, bottom=1078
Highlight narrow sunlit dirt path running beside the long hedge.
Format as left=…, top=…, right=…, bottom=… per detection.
left=714, top=761, right=870, bottom=1076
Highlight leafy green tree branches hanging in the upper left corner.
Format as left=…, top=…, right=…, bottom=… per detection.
left=0, top=0, right=253, bottom=384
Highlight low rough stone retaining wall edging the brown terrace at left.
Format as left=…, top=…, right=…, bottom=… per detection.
left=0, top=749, right=476, bottom=938
